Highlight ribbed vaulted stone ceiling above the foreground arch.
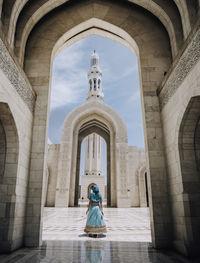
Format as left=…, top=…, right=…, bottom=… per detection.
left=0, top=0, right=200, bottom=76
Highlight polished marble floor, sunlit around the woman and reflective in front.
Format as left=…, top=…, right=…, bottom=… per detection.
left=0, top=208, right=200, bottom=263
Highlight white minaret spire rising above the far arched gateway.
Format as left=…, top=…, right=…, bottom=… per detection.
left=87, top=50, right=104, bottom=100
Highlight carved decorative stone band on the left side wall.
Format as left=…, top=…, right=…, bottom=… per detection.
left=0, top=39, right=35, bottom=112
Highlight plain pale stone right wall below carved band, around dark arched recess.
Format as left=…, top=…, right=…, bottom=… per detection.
left=162, top=58, right=200, bottom=254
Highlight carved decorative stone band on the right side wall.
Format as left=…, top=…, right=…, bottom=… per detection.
left=159, top=30, right=200, bottom=109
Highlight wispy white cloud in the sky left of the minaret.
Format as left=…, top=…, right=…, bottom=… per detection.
left=51, top=42, right=87, bottom=110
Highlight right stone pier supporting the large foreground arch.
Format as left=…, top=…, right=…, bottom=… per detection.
left=143, top=91, right=171, bottom=248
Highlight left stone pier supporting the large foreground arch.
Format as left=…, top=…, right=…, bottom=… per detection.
left=25, top=84, right=49, bottom=247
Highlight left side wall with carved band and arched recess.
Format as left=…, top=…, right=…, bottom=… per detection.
left=0, top=40, right=34, bottom=252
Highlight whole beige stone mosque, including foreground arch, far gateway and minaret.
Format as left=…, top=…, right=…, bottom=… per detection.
left=0, top=0, right=200, bottom=262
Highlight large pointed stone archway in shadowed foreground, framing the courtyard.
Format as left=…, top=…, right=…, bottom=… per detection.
left=0, top=0, right=200, bottom=254
